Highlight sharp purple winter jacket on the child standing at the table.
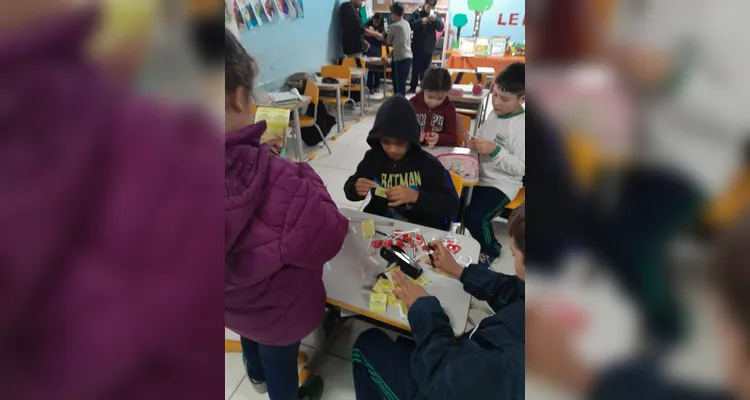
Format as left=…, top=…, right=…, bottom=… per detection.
left=224, top=122, right=349, bottom=345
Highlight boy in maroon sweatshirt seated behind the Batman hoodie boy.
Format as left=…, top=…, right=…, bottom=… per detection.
left=409, top=68, right=459, bottom=147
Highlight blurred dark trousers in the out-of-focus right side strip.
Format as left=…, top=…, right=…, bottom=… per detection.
left=586, top=168, right=703, bottom=344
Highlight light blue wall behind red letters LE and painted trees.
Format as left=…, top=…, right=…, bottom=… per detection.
left=449, top=0, right=526, bottom=42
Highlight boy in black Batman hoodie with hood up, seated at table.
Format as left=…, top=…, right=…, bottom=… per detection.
left=344, top=95, right=459, bottom=230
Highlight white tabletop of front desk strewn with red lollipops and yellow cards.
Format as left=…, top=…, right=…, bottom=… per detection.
left=323, top=208, right=480, bottom=336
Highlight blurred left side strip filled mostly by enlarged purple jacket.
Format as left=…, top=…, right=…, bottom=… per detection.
left=0, top=0, right=224, bottom=399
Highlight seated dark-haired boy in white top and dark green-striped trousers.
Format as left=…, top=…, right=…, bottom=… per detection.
left=464, top=63, right=526, bottom=267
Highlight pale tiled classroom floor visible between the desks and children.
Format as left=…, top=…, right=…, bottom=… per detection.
left=224, top=97, right=513, bottom=400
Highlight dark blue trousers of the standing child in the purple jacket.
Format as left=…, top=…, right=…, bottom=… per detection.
left=240, top=338, right=300, bottom=400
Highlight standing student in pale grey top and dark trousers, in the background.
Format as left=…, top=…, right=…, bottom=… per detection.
left=388, top=3, right=413, bottom=96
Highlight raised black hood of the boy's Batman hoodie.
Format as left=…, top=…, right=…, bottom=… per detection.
left=367, top=95, right=420, bottom=151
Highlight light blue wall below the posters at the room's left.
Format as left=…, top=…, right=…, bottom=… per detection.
left=240, top=0, right=345, bottom=92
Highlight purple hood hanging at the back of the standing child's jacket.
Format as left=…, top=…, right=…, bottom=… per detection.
left=224, top=121, right=270, bottom=250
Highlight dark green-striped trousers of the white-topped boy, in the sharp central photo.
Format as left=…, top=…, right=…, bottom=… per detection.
left=464, top=186, right=510, bottom=257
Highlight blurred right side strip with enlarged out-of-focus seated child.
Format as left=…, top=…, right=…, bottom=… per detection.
left=526, top=0, right=750, bottom=400
